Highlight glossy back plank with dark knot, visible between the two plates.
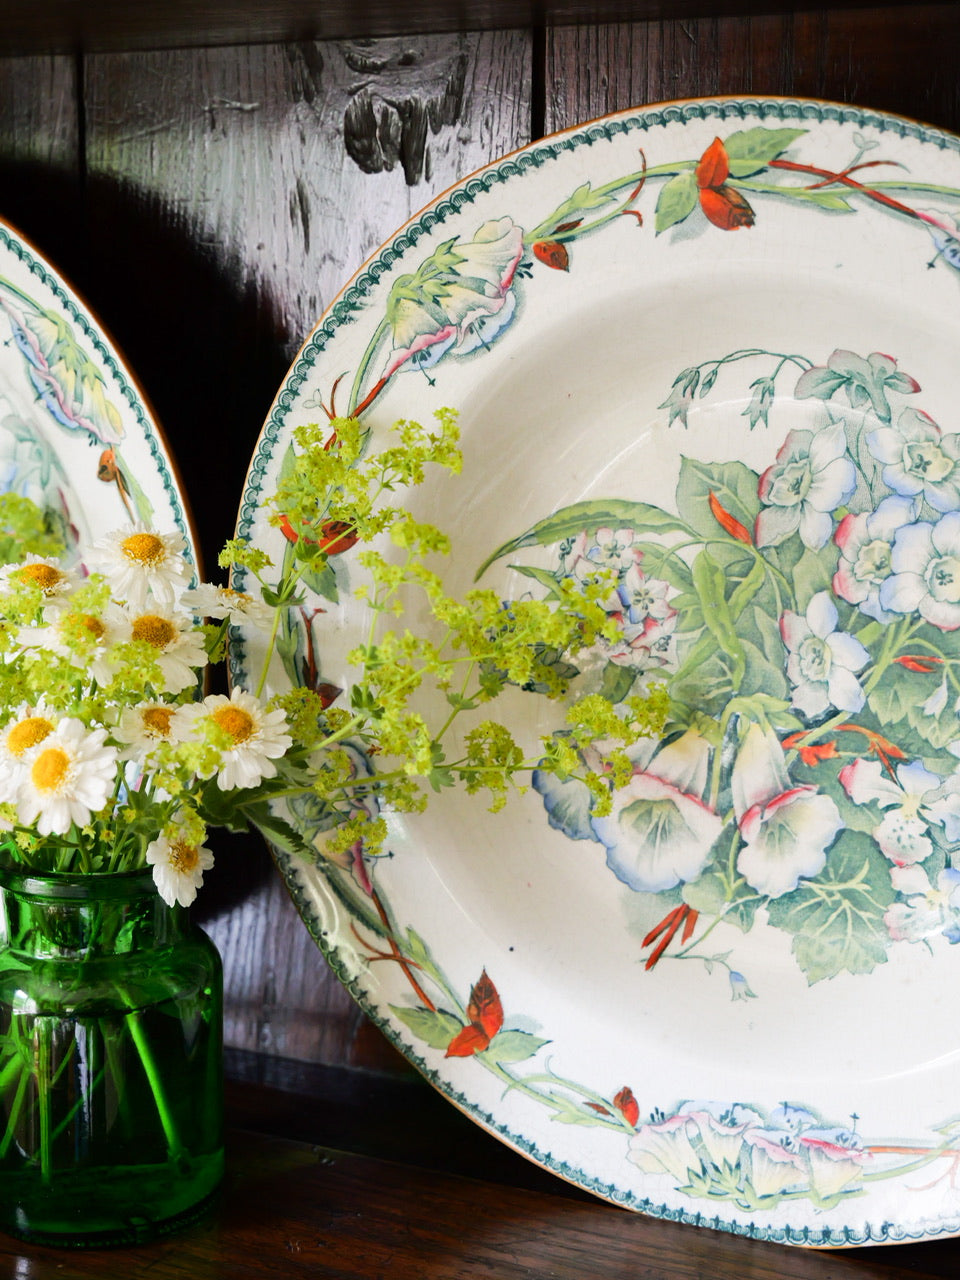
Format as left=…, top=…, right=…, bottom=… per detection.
left=76, top=33, right=530, bottom=1065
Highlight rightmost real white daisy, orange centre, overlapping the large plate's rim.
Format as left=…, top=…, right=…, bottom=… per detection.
left=184, top=689, right=293, bottom=791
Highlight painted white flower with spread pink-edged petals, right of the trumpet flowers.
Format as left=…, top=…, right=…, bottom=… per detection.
left=840, top=759, right=943, bottom=867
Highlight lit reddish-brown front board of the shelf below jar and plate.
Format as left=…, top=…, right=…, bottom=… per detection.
left=0, top=1105, right=960, bottom=1280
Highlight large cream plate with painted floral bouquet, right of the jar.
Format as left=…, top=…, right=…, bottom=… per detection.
left=236, top=99, right=960, bottom=1247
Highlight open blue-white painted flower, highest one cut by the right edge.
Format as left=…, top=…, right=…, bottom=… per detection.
left=867, top=408, right=960, bottom=511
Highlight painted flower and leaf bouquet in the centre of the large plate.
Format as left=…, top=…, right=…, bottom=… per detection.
left=488, top=351, right=960, bottom=995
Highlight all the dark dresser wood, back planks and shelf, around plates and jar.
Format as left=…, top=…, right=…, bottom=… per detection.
left=0, top=0, right=960, bottom=1280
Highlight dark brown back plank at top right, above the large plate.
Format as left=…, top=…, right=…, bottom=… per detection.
left=545, top=4, right=960, bottom=131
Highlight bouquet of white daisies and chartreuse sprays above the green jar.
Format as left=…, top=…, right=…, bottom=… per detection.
left=0, top=410, right=666, bottom=905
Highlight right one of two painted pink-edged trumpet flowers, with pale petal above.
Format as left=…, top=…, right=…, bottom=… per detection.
left=731, top=724, right=844, bottom=897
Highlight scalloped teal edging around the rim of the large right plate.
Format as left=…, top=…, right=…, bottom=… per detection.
left=230, top=99, right=960, bottom=1248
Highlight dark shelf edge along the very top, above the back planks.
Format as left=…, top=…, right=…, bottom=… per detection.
left=0, top=0, right=910, bottom=54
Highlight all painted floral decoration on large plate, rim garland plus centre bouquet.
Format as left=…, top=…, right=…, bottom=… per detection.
left=244, top=104, right=960, bottom=1244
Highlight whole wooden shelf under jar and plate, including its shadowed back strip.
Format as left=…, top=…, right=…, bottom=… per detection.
left=0, top=1055, right=960, bottom=1280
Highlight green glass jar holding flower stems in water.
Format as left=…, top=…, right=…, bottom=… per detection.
left=0, top=868, right=223, bottom=1245
